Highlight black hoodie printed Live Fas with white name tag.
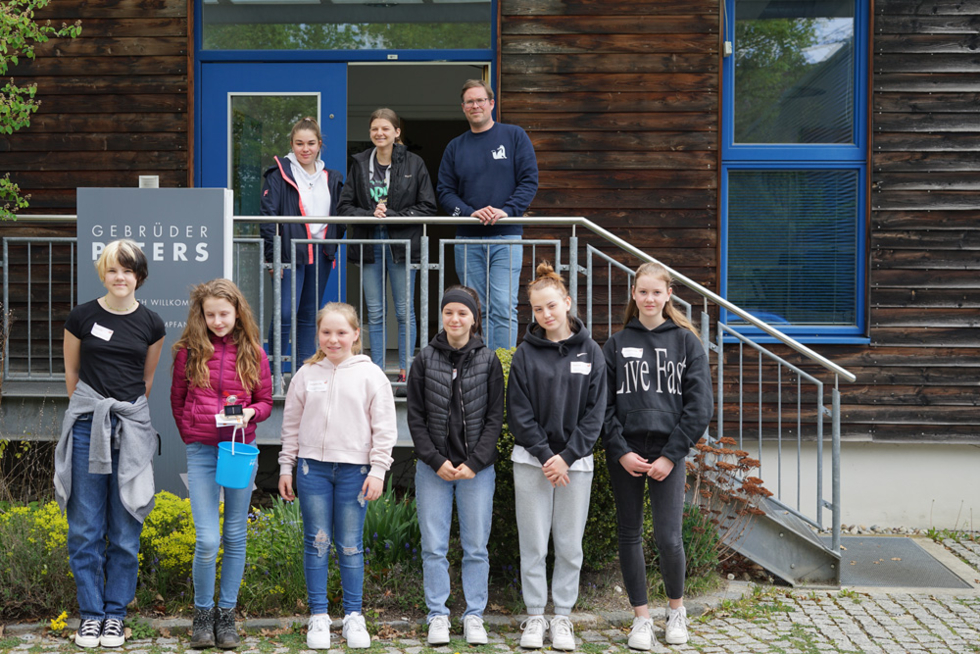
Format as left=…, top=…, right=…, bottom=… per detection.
left=602, top=318, right=714, bottom=465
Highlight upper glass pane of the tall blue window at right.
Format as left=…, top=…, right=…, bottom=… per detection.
left=734, top=0, right=855, bottom=144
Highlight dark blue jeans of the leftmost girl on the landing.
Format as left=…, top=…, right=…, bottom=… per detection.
left=269, top=251, right=333, bottom=372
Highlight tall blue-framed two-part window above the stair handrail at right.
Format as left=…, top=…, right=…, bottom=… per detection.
left=720, top=0, right=869, bottom=343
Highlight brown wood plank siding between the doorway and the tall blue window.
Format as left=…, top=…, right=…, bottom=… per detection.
left=498, top=0, right=721, bottom=346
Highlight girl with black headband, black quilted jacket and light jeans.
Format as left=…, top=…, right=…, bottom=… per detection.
left=408, top=286, right=504, bottom=645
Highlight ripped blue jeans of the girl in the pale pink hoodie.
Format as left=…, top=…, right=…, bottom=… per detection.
left=295, top=458, right=370, bottom=615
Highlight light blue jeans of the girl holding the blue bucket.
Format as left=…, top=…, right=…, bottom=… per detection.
left=187, top=443, right=254, bottom=609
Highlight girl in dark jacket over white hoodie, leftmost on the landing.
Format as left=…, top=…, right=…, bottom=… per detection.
left=260, top=116, right=344, bottom=370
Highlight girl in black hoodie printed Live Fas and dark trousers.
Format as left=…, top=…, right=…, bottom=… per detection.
left=602, top=263, right=713, bottom=650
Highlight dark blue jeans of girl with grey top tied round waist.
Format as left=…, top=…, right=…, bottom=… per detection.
left=66, top=414, right=143, bottom=620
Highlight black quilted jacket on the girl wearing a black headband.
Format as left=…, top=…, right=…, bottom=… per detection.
left=408, top=332, right=504, bottom=472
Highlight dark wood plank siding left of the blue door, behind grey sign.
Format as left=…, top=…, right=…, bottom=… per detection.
left=0, top=0, right=193, bottom=372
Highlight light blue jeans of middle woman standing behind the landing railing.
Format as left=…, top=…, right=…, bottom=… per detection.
left=361, top=227, right=415, bottom=370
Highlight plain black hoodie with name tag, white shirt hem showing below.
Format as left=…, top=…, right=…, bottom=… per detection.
left=507, top=318, right=606, bottom=465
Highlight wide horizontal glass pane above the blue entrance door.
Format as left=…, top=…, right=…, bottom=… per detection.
left=203, top=0, right=490, bottom=50
